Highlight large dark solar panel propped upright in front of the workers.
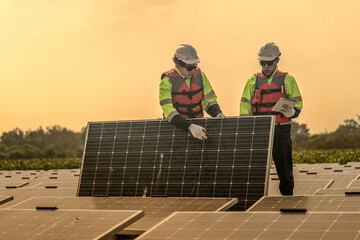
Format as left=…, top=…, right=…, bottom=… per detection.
left=77, top=116, right=274, bottom=210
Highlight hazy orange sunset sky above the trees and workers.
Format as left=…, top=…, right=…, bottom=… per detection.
left=0, top=0, right=360, bottom=134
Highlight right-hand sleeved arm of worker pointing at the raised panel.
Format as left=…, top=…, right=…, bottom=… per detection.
left=201, top=72, right=222, bottom=117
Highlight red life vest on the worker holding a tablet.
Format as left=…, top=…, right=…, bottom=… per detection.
left=251, top=71, right=290, bottom=123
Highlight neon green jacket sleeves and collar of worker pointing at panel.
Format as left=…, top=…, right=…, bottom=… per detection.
left=159, top=66, right=218, bottom=122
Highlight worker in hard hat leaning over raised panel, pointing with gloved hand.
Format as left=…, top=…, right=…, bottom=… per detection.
left=159, top=44, right=224, bottom=140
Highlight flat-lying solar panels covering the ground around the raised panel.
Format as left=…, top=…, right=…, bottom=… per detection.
left=0, top=163, right=360, bottom=239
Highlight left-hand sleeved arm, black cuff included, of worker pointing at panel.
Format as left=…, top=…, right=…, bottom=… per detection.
left=159, top=76, right=190, bottom=131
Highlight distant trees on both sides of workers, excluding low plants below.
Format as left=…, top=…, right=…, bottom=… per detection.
left=0, top=115, right=360, bottom=159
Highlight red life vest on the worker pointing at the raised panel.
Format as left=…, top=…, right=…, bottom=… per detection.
left=161, top=68, right=204, bottom=118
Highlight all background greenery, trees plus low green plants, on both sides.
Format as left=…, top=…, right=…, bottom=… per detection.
left=0, top=115, right=360, bottom=170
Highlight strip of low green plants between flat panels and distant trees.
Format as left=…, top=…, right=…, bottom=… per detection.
left=0, top=148, right=360, bottom=170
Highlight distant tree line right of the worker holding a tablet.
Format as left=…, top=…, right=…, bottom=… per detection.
left=291, top=115, right=360, bottom=151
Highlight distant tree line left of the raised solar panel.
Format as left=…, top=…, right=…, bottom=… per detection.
left=0, top=126, right=86, bottom=159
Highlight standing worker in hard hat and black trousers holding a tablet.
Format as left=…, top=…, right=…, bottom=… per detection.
left=240, top=42, right=303, bottom=195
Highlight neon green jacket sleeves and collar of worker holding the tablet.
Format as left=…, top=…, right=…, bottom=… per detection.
left=240, top=67, right=303, bottom=116
